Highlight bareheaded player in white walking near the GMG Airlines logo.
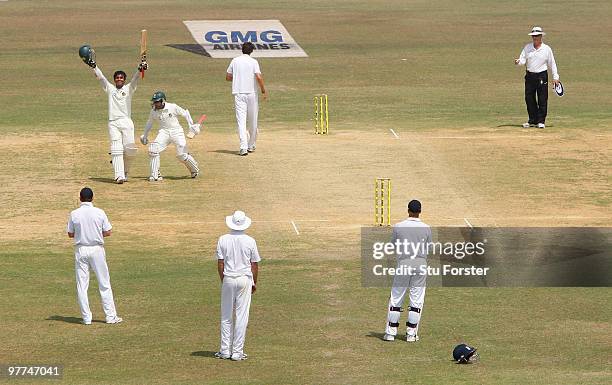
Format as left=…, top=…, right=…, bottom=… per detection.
left=225, top=42, right=268, bottom=156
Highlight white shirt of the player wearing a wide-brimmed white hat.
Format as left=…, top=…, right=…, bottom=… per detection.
left=217, top=231, right=261, bottom=277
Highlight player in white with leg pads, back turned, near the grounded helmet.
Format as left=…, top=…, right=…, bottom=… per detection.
left=383, top=200, right=431, bottom=342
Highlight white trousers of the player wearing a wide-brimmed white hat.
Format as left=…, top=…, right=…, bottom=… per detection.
left=219, top=276, right=252, bottom=354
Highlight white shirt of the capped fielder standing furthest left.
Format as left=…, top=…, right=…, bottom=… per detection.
left=67, top=202, right=112, bottom=246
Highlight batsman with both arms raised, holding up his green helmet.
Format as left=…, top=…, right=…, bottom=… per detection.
left=79, top=38, right=147, bottom=184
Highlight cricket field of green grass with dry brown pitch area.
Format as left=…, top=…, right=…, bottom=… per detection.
left=0, top=0, right=612, bottom=384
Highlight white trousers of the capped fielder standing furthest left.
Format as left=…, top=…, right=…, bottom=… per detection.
left=74, top=246, right=117, bottom=322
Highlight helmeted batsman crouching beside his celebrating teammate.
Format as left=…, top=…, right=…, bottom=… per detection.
left=140, top=91, right=200, bottom=182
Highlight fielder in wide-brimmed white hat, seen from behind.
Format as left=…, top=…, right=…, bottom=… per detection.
left=215, top=211, right=261, bottom=361
